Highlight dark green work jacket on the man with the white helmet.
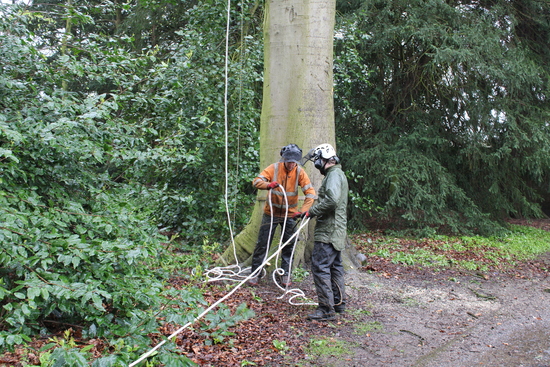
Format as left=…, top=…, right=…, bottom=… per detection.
left=309, top=164, right=349, bottom=251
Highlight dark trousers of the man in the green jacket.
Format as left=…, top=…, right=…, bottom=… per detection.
left=311, top=242, right=346, bottom=313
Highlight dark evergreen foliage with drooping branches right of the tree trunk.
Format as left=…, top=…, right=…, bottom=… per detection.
left=335, top=0, right=550, bottom=234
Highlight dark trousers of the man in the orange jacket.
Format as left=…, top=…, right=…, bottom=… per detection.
left=251, top=214, right=296, bottom=276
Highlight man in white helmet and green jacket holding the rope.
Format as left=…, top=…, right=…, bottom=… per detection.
left=301, top=144, right=348, bottom=320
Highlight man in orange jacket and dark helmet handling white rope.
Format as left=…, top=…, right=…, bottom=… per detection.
left=248, top=144, right=317, bottom=286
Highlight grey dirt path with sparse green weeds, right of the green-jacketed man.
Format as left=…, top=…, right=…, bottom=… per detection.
left=300, top=264, right=550, bottom=367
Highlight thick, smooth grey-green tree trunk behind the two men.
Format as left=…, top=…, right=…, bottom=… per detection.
left=223, top=0, right=364, bottom=269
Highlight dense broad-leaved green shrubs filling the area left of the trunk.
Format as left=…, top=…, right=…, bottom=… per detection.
left=0, top=3, right=260, bottom=366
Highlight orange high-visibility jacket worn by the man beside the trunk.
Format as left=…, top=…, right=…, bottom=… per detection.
left=252, top=162, right=317, bottom=218
